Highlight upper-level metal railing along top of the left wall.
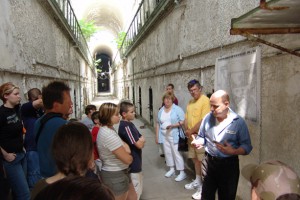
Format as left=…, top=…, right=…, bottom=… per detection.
left=48, top=0, right=93, bottom=66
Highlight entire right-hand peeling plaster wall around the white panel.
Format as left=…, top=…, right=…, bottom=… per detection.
left=115, top=0, right=300, bottom=200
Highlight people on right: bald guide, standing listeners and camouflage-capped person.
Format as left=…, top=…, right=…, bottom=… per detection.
left=156, top=79, right=300, bottom=200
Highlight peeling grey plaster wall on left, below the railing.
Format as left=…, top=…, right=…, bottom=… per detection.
left=0, top=0, right=96, bottom=117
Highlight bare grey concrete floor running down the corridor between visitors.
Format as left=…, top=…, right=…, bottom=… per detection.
left=91, top=94, right=196, bottom=200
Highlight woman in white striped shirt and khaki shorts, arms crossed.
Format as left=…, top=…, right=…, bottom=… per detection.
left=96, top=103, right=137, bottom=200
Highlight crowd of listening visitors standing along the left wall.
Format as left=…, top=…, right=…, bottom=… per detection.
left=0, top=81, right=145, bottom=200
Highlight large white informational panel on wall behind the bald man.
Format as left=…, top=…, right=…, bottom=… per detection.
left=215, top=47, right=261, bottom=122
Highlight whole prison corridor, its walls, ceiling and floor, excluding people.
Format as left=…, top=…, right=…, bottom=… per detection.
left=0, top=0, right=300, bottom=200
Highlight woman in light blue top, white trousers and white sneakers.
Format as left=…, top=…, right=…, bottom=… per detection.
left=156, top=93, right=186, bottom=181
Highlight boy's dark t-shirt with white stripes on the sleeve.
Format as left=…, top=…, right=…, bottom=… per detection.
left=118, top=120, right=142, bottom=173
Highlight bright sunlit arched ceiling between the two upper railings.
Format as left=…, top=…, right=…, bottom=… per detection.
left=71, top=0, right=140, bottom=58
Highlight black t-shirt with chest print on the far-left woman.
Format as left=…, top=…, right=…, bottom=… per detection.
left=0, top=105, right=23, bottom=153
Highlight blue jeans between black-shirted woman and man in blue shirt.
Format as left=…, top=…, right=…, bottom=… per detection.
left=26, top=151, right=42, bottom=189
